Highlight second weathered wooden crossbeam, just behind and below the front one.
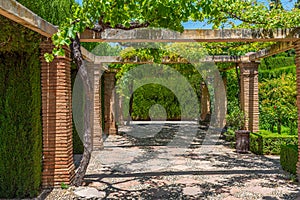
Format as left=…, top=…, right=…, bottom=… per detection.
left=94, top=56, right=250, bottom=64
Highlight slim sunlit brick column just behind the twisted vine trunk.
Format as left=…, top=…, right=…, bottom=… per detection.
left=93, top=65, right=103, bottom=151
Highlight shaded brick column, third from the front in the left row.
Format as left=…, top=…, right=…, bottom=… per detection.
left=104, top=71, right=118, bottom=134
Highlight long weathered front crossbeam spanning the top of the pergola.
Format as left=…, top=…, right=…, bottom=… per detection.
left=80, top=29, right=299, bottom=42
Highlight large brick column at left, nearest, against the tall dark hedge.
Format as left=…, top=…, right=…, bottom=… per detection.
left=40, top=41, right=74, bottom=188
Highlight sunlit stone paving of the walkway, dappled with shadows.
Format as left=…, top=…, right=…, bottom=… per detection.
left=48, top=124, right=300, bottom=200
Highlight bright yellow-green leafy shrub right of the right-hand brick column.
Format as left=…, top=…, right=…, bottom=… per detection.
left=259, top=74, right=298, bottom=134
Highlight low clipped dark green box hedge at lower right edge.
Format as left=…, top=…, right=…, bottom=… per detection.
left=280, top=145, right=298, bottom=174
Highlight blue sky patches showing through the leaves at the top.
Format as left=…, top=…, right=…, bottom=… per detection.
left=75, top=0, right=296, bottom=29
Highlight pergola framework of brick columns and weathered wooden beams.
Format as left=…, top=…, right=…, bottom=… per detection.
left=0, top=0, right=300, bottom=188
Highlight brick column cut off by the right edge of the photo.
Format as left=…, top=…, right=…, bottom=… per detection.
left=295, top=40, right=300, bottom=181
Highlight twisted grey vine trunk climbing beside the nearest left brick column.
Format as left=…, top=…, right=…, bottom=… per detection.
left=71, top=36, right=92, bottom=186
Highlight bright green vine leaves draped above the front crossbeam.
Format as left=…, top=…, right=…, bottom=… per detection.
left=44, top=0, right=300, bottom=61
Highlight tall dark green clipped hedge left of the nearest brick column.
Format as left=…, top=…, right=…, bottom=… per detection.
left=0, top=17, right=42, bottom=198
